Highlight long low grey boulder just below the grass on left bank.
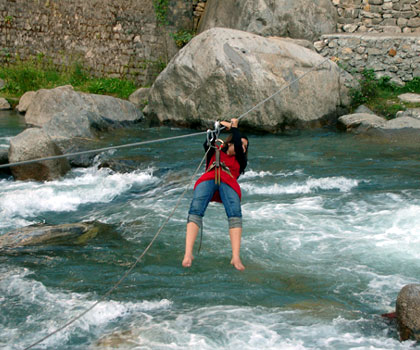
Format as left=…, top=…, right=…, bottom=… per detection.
left=25, top=85, right=143, bottom=127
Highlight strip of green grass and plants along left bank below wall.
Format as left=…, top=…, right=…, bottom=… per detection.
left=0, top=55, right=137, bottom=99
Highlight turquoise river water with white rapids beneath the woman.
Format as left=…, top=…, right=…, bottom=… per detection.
left=0, top=110, right=420, bottom=350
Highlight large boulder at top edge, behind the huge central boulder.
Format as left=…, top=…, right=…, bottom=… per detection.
left=198, top=0, right=337, bottom=42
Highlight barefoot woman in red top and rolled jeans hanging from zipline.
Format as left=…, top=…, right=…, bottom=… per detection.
left=182, top=119, right=249, bottom=271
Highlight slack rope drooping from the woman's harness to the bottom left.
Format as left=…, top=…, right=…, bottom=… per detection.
left=24, top=149, right=210, bottom=350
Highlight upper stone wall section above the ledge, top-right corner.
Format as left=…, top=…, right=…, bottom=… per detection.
left=331, top=0, right=420, bottom=33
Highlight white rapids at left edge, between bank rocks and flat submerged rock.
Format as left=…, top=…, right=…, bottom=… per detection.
left=0, top=167, right=158, bottom=229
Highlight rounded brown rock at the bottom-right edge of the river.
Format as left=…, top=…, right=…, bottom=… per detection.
left=396, top=284, right=420, bottom=341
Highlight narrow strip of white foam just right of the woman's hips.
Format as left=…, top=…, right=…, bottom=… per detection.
left=241, top=177, right=359, bottom=195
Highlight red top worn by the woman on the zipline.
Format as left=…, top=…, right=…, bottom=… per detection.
left=194, top=151, right=242, bottom=203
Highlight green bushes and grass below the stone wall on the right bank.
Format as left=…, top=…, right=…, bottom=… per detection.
left=351, top=69, right=420, bottom=119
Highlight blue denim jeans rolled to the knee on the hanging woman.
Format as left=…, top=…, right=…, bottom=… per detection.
left=188, top=180, right=242, bottom=228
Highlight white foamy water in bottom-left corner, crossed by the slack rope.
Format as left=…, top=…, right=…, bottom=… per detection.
left=0, top=267, right=172, bottom=349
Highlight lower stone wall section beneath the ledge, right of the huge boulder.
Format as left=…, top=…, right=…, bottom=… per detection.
left=314, top=33, right=420, bottom=85
